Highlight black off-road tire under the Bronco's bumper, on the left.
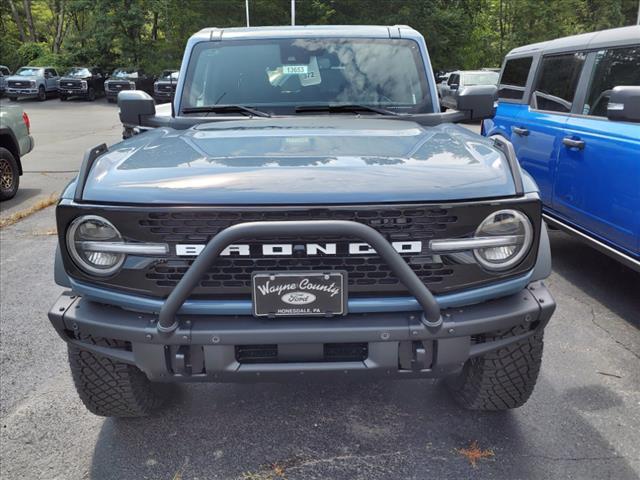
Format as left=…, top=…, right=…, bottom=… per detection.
left=68, top=338, right=168, bottom=417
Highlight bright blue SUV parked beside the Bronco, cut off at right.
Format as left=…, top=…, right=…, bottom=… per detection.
left=483, top=26, right=640, bottom=271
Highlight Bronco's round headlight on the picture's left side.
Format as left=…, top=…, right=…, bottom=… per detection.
left=67, top=215, right=125, bottom=276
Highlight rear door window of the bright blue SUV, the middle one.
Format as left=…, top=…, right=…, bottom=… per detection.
left=532, top=53, right=586, bottom=113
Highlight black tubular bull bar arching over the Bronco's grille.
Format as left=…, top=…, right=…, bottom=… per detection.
left=157, top=220, right=442, bottom=335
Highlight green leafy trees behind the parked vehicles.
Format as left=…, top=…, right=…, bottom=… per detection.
left=0, top=0, right=638, bottom=73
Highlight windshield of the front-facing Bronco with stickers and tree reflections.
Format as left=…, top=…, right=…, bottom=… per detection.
left=181, top=38, right=433, bottom=113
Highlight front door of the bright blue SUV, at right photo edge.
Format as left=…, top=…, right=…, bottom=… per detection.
left=553, top=46, right=640, bottom=255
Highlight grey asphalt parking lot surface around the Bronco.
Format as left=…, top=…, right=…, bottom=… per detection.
left=0, top=99, right=640, bottom=480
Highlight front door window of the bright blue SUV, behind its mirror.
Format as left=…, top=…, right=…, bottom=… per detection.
left=582, top=45, right=640, bottom=117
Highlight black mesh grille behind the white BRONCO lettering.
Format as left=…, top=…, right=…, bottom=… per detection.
left=139, top=208, right=457, bottom=294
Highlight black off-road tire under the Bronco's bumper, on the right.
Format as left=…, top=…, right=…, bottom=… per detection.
left=446, top=326, right=544, bottom=411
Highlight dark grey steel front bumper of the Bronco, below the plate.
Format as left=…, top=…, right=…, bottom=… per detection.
left=49, top=282, right=555, bottom=382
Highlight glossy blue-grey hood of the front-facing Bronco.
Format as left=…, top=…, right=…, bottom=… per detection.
left=84, top=116, right=515, bottom=205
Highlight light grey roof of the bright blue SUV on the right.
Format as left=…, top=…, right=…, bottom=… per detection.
left=507, top=25, right=640, bottom=57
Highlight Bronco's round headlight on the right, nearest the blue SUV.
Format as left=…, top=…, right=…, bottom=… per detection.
left=473, top=210, right=533, bottom=270
